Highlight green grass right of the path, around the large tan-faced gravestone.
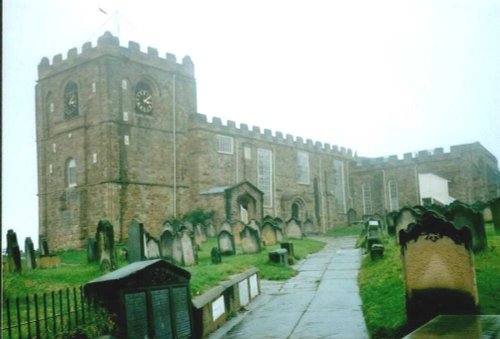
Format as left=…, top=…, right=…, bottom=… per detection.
left=358, top=223, right=500, bottom=338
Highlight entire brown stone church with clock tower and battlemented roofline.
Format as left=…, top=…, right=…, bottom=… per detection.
left=36, top=32, right=500, bottom=250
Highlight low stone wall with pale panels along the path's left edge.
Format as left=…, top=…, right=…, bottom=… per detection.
left=192, top=268, right=260, bottom=338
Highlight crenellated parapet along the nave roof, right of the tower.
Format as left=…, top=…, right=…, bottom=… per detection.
left=191, top=113, right=353, bottom=159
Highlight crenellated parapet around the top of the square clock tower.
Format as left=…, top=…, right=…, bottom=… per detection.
left=38, top=32, right=194, bottom=79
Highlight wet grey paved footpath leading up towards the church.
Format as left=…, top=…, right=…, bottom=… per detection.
left=209, top=237, right=369, bottom=339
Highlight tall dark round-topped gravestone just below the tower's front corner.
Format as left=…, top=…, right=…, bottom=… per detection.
left=95, top=220, right=118, bottom=272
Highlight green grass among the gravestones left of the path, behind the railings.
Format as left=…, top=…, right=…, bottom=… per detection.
left=2, top=239, right=325, bottom=299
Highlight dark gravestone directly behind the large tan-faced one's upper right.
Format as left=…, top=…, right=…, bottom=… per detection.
left=446, top=203, right=488, bottom=252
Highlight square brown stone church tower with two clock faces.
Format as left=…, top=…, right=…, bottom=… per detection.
left=36, top=32, right=196, bottom=249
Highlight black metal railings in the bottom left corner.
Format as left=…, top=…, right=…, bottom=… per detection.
left=1, top=287, right=96, bottom=338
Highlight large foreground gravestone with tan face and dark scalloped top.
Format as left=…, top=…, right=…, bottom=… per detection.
left=398, top=212, right=478, bottom=327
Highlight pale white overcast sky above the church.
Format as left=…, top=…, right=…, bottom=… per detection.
left=2, top=0, right=500, bottom=248
